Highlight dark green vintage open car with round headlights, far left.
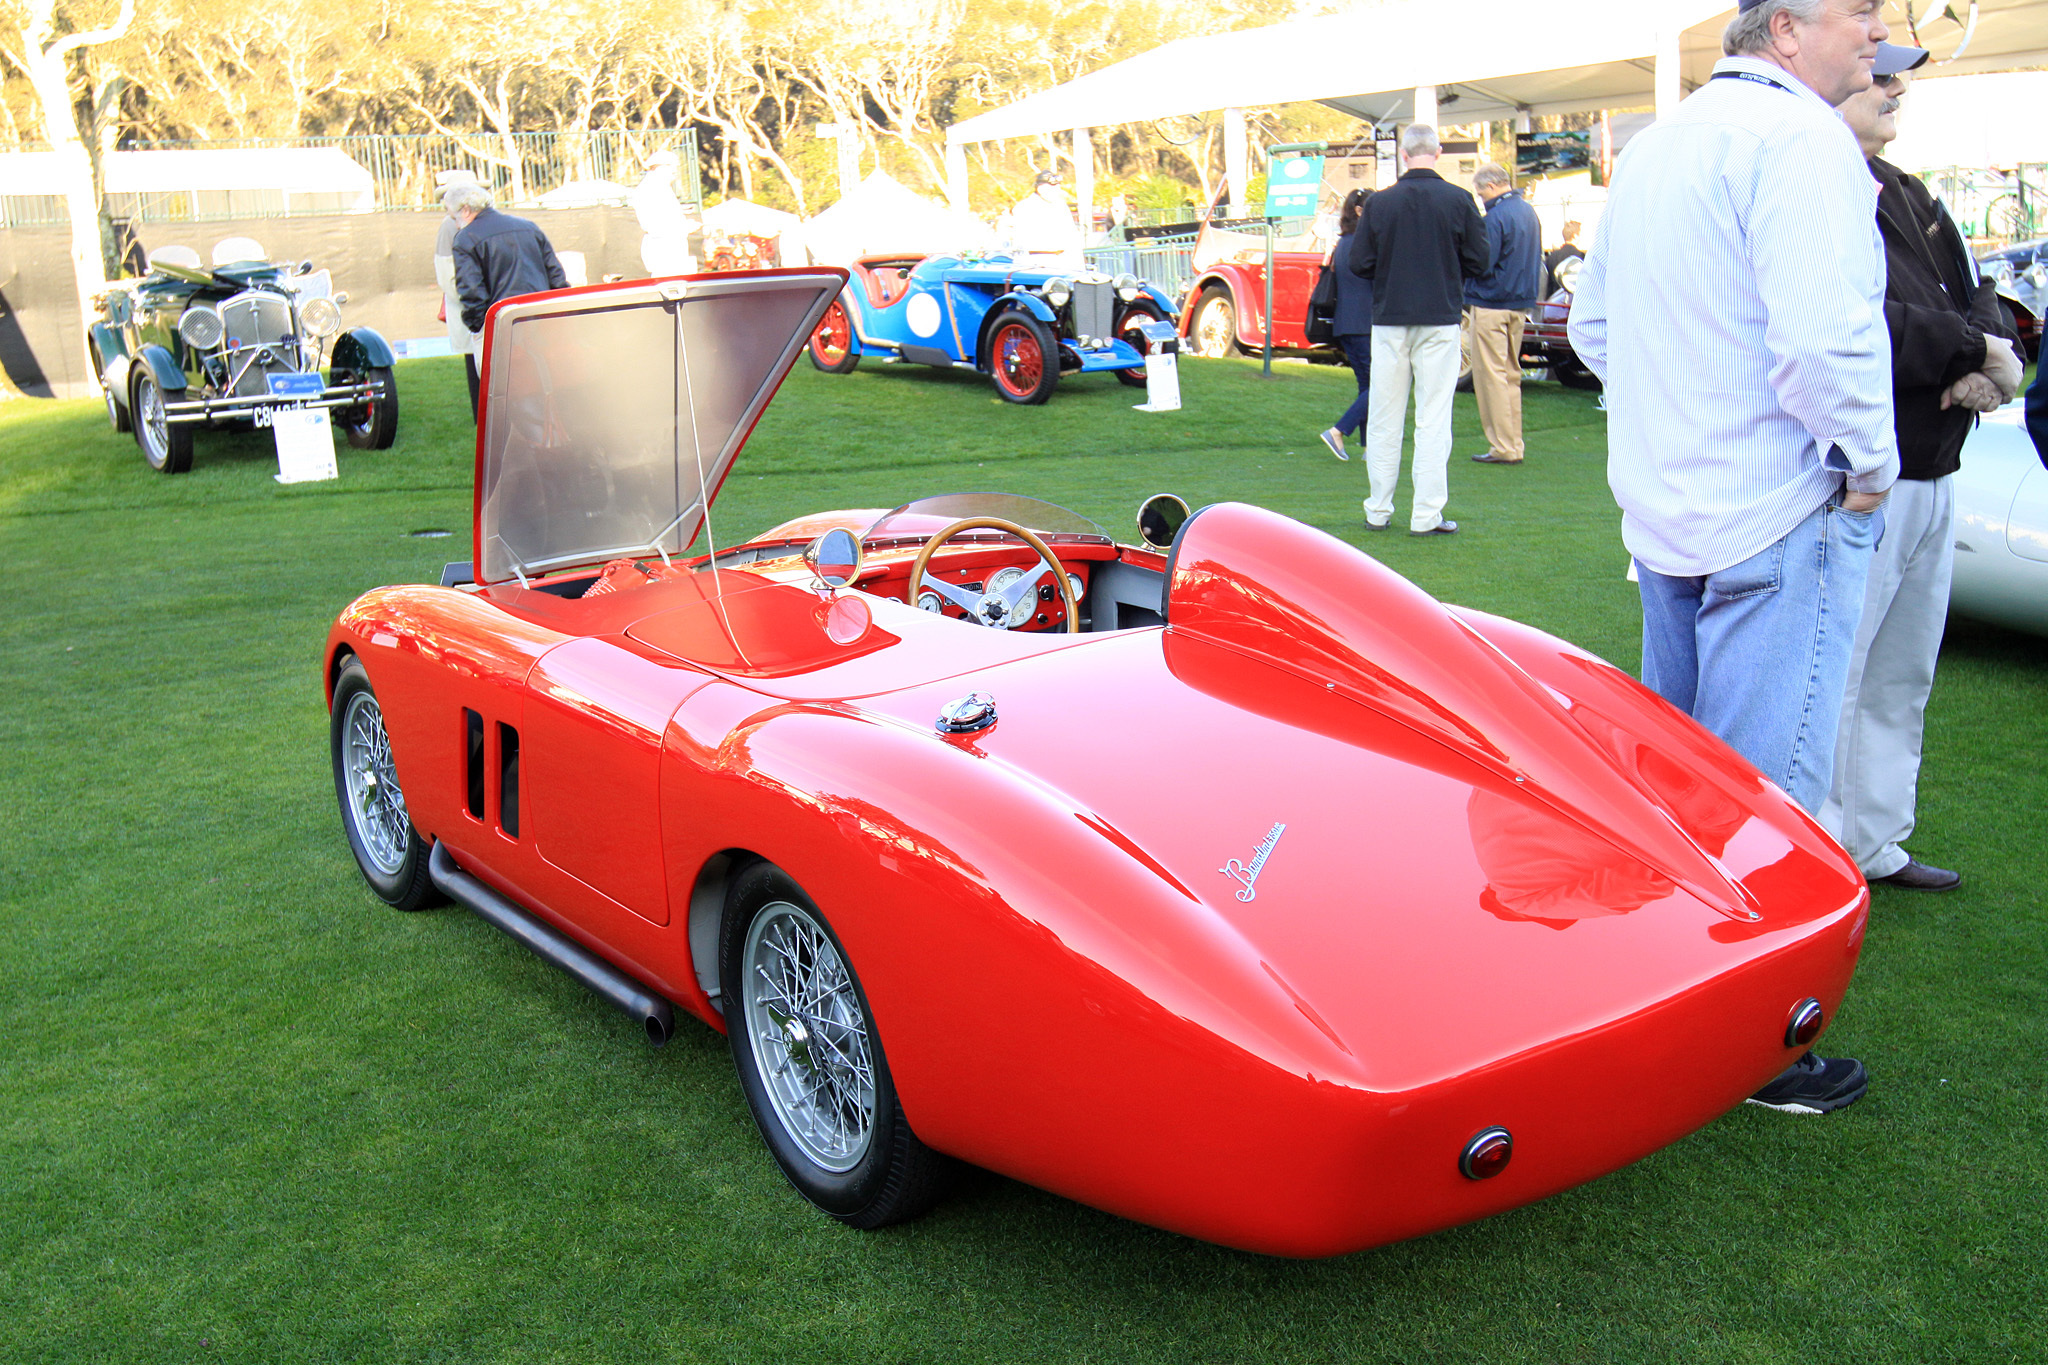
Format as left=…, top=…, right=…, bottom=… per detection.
left=88, top=237, right=397, bottom=475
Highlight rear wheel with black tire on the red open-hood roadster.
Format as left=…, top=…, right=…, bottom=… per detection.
left=719, top=862, right=954, bottom=1228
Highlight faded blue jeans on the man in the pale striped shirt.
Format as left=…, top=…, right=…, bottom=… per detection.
left=1636, top=501, right=1884, bottom=812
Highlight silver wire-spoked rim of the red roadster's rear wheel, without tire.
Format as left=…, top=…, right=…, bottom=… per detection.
left=739, top=900, right=874, bottom=1173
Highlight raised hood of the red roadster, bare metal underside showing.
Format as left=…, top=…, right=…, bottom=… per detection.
left=475, top=268, right=846, bottom=583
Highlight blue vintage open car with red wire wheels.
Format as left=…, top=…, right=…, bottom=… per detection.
left=811, top=256, right=1176, bottom=403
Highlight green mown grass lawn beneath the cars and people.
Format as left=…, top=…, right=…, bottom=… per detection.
left=0, top=360, right=2048, bottom=1365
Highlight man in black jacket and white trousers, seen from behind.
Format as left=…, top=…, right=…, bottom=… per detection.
left=1352, top=123, right=1493, bottom=536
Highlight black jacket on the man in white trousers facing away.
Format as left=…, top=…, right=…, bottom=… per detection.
left=1352, top=168, right=1493, bottom=327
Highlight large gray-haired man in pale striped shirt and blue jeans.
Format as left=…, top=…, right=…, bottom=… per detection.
left=1571, top=0, right=1898, bottom=1113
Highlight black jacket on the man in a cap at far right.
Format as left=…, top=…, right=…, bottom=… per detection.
left=1870, top=158, right=2017, bottom=479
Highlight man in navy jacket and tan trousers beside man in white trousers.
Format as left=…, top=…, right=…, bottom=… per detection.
left=1464, top=162, right=1544, bottom=465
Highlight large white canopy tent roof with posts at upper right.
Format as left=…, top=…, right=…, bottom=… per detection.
left=946, top=0, right=2048, bottom=207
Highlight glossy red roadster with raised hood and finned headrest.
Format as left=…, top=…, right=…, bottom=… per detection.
left=324, top=270, right=1868, bottom=1257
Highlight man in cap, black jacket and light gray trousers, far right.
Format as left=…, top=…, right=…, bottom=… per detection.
left=1819, top=43, right=2023, bottom=890
